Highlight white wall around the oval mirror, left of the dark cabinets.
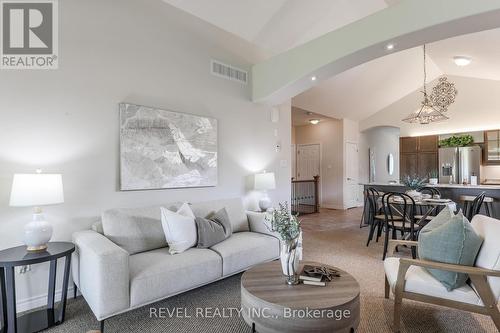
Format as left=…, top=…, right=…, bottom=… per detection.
left=359, top=126, right=399, bottom=183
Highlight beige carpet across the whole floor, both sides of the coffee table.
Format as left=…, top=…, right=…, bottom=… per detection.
left=44, top=209, right=497, bottom=333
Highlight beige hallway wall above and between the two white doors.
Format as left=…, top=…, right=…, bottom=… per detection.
left=295, top=119, right=343, bottom=208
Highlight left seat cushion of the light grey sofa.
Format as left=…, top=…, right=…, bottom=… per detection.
left=129, top=248, right=222, bottom=307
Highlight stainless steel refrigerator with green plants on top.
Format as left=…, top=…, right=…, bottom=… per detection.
left=439, top=146, right=482, bottom=184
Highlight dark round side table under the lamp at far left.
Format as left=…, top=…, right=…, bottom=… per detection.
left=0, top=242, right=75, bottom=333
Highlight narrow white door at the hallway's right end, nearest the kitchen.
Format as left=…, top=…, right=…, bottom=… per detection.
left=344, top=142, right=359, bottom=208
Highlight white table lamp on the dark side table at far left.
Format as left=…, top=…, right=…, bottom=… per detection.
left=9, top=170, right=64, bottom=252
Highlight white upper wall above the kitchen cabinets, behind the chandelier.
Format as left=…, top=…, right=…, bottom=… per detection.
left=360, top=76, right=500, bottom=136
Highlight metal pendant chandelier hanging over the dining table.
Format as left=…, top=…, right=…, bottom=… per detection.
left=403, top=45, right=457, bottom=125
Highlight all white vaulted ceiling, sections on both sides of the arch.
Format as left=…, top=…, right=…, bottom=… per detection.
left=163, top=0, right=500, bottom=124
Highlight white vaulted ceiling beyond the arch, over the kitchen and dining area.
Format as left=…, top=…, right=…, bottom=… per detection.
left=292, top=29, right=500, bottom=120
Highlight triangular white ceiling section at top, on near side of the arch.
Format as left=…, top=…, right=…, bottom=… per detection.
left=163, top=0, right=399, bottom=55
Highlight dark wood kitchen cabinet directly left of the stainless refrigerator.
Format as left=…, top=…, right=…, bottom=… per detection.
left=399, top=135, right=438, bottom=178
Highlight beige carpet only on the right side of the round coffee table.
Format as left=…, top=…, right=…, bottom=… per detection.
left=302, top=209, right=497, bottom=333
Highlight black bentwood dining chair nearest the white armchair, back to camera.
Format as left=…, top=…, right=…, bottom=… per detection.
left=382, top=192, right=419, bottom=260
